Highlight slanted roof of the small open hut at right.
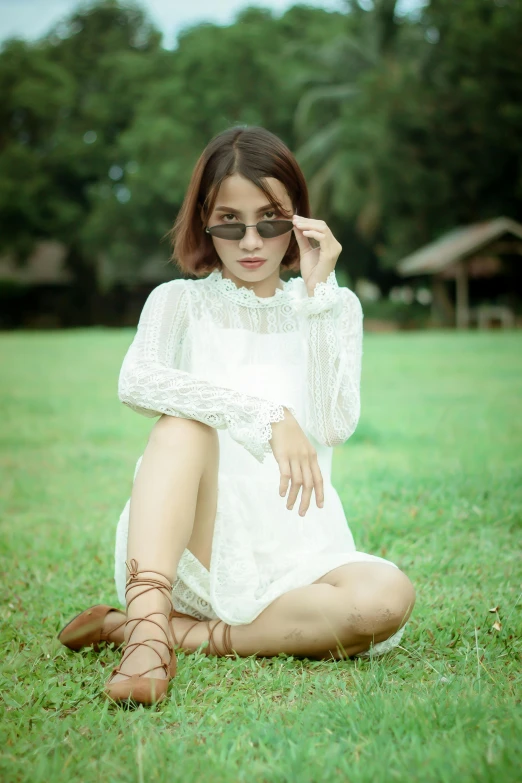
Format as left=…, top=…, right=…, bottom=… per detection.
left=397, top=217, right=522, bottom=277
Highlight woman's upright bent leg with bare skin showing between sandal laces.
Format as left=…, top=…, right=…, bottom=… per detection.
left=108, top=416, right=219, bottom=683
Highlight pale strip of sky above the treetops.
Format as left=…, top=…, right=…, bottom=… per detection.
left=0, top=0, right=422, bottom=48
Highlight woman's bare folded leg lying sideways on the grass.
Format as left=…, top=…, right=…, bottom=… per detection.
left=173, top=563, right=415, bottom=659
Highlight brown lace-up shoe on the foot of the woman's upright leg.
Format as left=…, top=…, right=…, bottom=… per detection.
left=105, top=560, right=177, bottom=705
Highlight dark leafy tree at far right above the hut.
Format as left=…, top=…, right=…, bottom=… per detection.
left=382, top=0, right=522, bottom=264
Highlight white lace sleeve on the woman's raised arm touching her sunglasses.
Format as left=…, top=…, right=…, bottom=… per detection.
left=292, top=271, right=363, bottom=446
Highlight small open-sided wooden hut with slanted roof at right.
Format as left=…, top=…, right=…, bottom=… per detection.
left=397, top=217, right=522, bottom=329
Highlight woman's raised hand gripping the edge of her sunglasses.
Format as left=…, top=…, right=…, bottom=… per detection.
left=292, top=215, right=343, bottom=296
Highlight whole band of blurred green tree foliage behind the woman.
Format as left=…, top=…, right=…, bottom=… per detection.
left=0, top=0, right=522, bottom=318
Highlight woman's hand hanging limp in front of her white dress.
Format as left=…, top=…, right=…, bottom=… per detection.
left=270, top=408, right=324, bottom=517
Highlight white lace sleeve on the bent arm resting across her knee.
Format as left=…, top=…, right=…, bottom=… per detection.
left=118, top=280, right=295, bottom=462
